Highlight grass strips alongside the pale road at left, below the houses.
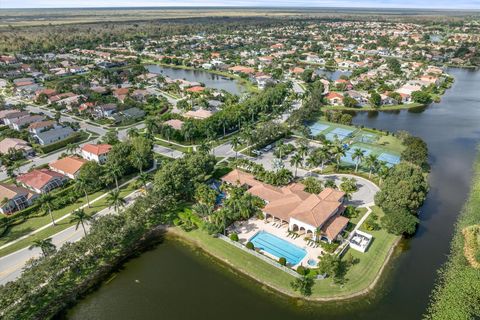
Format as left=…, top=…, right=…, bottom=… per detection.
left=0, top=181, right=135, bottom=257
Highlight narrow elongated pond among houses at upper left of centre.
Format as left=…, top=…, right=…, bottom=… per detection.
left=146, top=65, right=246, bottom=95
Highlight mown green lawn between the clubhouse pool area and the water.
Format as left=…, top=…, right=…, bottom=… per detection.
left=172, top=212, right=398, bottom=300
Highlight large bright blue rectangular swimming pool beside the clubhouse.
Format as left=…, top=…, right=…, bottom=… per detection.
left=250, top=231, right=307, bottom=265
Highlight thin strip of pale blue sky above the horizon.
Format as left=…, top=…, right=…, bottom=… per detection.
left=0, top=0, right=480, bottom=9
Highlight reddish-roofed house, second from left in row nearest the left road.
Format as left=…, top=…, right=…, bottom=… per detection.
left=17, top=169, right=66, bottom=194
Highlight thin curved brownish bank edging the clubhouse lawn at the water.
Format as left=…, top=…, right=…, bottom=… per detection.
left=166, top=227, right=402, bottom=302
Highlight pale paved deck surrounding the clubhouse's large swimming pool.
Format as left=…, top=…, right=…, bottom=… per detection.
left=231, top=218, right=324, bottom=268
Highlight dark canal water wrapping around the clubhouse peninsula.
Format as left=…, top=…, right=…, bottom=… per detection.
left=66, top=69, right=480, bottom=320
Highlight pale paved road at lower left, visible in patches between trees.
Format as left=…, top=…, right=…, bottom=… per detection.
left=0, top=190, right=141, bottom=284
